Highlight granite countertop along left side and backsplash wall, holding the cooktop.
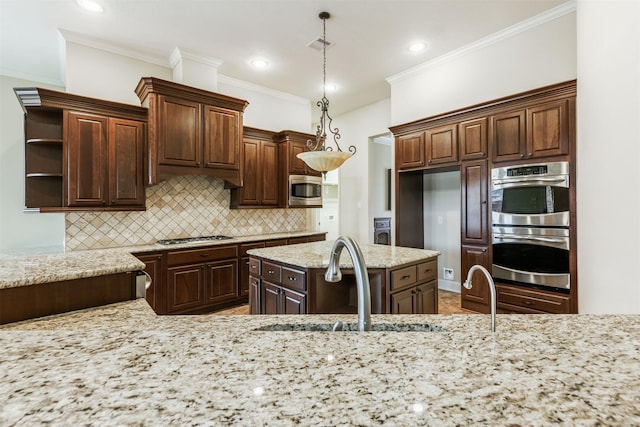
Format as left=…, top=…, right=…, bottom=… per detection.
left=0, top=232, right=324, bottom=289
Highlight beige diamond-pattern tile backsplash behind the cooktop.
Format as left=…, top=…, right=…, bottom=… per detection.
left=65, top=176, right=307, bottom=250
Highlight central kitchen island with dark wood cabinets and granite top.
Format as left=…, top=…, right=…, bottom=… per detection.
left=247, top=241, right=440, bottom=314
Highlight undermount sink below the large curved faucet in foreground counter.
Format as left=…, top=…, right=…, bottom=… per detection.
left=254, top=323, right=447, bottom=332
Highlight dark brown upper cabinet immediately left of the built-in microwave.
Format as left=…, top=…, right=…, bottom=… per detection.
left=231, top=127, right=281, bottom=208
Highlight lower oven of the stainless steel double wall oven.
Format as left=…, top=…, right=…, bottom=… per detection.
left=492, top=227, right=571, bottom=289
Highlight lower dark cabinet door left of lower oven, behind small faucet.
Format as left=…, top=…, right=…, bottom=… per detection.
left=461, top=245, right=491, bottom=313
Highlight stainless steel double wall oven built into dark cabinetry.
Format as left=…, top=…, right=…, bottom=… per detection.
left=491, top=162, right=571, bottom=293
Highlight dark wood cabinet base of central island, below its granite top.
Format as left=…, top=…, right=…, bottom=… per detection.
left=249, top=256, right=438, bottom=314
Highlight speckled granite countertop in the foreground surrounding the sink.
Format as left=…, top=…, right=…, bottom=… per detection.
left=0, top=300, right=640, bottom=426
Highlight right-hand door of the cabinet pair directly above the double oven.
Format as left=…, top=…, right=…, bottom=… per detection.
left=527, top=99, right=569, bottom=157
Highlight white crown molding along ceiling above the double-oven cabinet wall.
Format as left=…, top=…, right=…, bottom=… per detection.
left=385, top=0, right=576, bottom=84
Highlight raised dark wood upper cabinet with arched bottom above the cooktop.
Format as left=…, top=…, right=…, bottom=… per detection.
left=136, top=77, right=248, bottom=187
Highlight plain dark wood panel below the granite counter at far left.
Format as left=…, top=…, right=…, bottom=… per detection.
left=0, top=272, right=136, bottom=324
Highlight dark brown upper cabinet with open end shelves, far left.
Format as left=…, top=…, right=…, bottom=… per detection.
left=15, top=88, right=147, bottom=212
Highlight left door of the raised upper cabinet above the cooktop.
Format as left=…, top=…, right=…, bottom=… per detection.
left=158, top=95, right=202, bottom=167
